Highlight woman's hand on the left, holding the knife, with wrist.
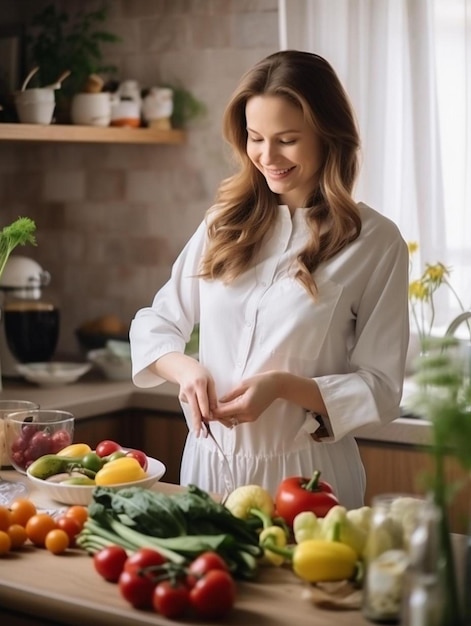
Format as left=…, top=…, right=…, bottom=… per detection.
left=152, top=352, right=217, bottom=437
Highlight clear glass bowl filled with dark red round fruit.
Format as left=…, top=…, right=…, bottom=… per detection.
left=4, top=409, right=75, bottom=474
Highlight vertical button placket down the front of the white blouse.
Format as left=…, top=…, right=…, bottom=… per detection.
left=232, top=214, right=292, bottom=375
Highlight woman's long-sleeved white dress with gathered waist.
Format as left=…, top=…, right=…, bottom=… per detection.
left=130, top=204, right=409, bottom=508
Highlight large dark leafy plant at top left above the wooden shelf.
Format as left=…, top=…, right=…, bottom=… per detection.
left=26, top=4, right=120, bottom=99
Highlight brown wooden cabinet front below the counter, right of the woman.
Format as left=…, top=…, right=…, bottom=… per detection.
left=358, top=440, right=471, bottom=534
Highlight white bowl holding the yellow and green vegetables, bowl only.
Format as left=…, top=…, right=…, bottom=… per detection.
left=26, top=457, right=166, bottom=506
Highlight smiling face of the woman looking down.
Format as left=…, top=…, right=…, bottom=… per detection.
left=245, top=96, right=323, bottom=212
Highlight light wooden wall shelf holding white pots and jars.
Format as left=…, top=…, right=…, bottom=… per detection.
left=0, top=124, right=185, bottom=144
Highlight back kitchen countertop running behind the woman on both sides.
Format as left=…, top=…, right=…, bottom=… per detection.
left=0, top=372, right=430, bottom=446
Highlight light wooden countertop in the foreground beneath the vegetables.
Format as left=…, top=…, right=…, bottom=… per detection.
left=0, top=471, right=368, bottom=626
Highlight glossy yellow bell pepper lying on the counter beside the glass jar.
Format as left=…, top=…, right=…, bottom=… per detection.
left=292, top=539, right=358, bottom=583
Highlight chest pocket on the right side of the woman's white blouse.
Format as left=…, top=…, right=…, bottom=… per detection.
left=258, top=272, right=342, bottom=360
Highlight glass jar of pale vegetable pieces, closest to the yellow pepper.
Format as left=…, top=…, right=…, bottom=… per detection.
left=363, top=494, right=423, bottom=624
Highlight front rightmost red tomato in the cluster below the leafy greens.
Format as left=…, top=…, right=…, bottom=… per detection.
left=190, top=569, right=236, bottom=619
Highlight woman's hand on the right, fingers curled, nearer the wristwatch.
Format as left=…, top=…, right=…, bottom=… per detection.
left=213, top=372, right=278, bottom=428
